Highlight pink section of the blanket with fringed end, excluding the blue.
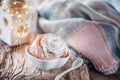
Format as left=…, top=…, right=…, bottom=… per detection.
left=66, top=22, right=118, bottom=74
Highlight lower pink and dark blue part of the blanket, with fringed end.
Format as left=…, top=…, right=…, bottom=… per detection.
left=66, top=22, right=120, bottom=74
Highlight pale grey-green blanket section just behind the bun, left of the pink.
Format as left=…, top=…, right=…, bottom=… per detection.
left=39, top=18, right=86, bottom=38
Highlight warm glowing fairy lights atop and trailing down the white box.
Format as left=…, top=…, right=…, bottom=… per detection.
left=2, top=0, right=32, bottom=44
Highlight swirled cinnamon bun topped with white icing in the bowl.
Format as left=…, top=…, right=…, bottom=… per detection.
left=30, top=34, right=69, bottom=59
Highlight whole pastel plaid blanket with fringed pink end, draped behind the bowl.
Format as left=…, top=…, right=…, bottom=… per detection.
left=38, top=0, right=120, bottom=74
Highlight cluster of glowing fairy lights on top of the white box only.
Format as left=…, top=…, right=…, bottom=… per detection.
left=2, top=0, right=32, bottom=14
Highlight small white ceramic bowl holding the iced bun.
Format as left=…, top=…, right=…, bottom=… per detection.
left=25, top=46, right=71, bottom=70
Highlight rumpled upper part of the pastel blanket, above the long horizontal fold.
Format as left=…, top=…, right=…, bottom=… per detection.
left=38, top=0, right=120, bottom=28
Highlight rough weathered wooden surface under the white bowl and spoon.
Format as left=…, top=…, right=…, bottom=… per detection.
left=0, top=41, right=90, bottom=80
